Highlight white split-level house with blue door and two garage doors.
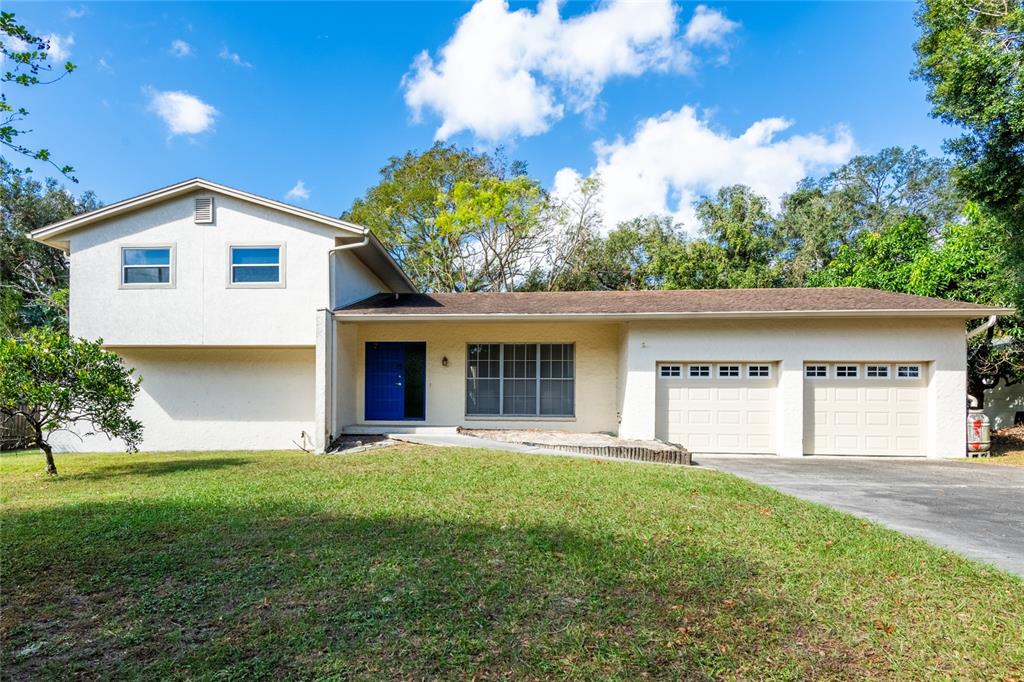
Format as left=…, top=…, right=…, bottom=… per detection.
left=33, top=179, right=1012, bottom=457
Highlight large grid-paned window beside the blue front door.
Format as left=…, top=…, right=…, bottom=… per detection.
left=466, top=343, right=575, bottom=417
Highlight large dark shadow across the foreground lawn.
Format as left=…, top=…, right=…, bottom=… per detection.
left=0, top=493, right=849, bottom=679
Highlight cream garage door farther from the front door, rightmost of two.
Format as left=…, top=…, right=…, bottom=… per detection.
left=804, top=363, right=927, bottom=456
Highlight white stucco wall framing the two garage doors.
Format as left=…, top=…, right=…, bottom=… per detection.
left=620, top=318, right=967, bottom=457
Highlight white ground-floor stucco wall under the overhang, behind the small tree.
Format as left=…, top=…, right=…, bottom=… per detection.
left=50, top=348, right=315, bottom=452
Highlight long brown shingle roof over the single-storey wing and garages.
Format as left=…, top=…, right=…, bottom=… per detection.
left=337, top=289, right=1012, bottom=317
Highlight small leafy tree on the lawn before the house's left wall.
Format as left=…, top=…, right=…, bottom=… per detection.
left=0, top=328, right=142, bottom=475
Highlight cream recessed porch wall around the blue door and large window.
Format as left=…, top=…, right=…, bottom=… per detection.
left=337, top=322, right=620, bottom=432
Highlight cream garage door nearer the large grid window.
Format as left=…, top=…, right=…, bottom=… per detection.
left=655, top=361, right=776, bottom=453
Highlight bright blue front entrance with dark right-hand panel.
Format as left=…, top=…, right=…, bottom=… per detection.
left=365, top=342, right=426, bottom=421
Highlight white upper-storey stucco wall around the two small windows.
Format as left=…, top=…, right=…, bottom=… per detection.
left=69, top=188, right=385, bottom=346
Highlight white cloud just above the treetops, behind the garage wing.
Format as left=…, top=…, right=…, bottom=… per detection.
left=552, top=106, right=856, bottom=232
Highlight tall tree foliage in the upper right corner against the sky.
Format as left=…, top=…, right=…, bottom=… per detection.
left=914, top=0, right=1024, bottom=308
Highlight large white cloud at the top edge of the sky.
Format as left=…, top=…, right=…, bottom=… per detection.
left=402, top=0, right=731, bottom=140
